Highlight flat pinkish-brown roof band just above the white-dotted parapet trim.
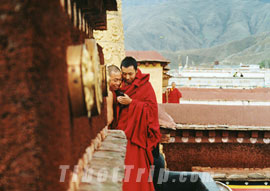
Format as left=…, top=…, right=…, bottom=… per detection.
left=160, top=101, right=270, bottom=127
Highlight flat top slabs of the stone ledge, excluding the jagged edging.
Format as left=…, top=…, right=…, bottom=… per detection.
left=79, top=130, right=127, bottom=191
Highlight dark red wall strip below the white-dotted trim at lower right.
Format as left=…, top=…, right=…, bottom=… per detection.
left=163, top=143, right=270, bottom=171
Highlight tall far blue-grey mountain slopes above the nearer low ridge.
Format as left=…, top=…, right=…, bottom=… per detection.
left=123, top=0, right=270, bottom=67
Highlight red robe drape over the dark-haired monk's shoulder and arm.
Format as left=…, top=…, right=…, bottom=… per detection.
left=125, top=84, right=161, bottom=149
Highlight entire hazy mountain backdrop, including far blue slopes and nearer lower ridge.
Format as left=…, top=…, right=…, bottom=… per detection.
left=123, top=0, right=270, bottom=68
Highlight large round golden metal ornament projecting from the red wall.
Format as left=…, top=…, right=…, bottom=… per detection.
left=67, top=39, right=107, bottom=117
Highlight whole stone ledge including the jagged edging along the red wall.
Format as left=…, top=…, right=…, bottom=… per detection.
left=68, top=127, right=127, bottom=191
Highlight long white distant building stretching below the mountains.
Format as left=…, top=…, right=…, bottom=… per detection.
left=169, top=66, right=270, bottom=88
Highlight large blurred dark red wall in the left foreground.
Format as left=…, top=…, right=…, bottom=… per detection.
left=0, top=0, right=106, bottom=191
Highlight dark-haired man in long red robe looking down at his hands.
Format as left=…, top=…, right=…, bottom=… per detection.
left=117, top=57, right=161, bottom=191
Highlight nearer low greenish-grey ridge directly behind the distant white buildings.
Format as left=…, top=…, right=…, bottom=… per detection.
left=161, top=32, right=270, bottom=68
